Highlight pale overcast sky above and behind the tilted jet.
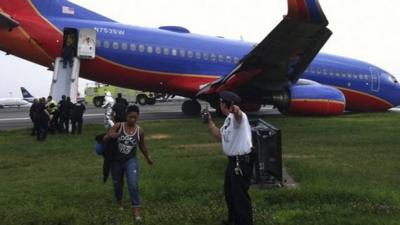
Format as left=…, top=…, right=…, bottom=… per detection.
left=0, top=0, right=400, bottom=97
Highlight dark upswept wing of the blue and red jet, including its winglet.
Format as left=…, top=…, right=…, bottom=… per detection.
left=197, top=0, right=332, bottom=98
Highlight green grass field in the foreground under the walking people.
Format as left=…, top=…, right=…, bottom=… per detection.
left=0, top=113, right=400, bottom=225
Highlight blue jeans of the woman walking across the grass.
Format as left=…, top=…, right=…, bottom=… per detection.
left=111, top=158, right=140, bottom=208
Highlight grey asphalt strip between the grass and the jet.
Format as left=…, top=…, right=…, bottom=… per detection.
left=0, top=101, right=279, bottom=130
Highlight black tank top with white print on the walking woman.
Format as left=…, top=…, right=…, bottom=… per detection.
left=113, top=123, right=140, bottom=162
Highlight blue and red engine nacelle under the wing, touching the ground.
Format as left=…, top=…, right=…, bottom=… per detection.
left=287, top=84, right=346, bottom=116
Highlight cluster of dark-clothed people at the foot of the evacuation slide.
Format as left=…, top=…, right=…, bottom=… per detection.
left=29, top=95, right=86, bottom=141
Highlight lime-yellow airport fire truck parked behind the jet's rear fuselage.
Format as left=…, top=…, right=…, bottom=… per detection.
left=85, top=83, right=161, bottom=107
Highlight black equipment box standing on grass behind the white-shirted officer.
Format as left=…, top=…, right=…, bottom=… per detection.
left=250, top=119, right=283, bottom=185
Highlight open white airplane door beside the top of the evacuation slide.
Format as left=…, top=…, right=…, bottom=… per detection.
left=78, top=29, right=96, bottom=59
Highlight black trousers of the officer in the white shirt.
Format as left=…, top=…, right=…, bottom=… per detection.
left=224, top=157, right=253, bottom=225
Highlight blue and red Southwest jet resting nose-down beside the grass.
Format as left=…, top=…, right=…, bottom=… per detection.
left=0, top=0, right=400, bottom=116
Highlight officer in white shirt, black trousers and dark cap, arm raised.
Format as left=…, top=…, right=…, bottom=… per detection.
left=208, top=91, right=253, bottom=225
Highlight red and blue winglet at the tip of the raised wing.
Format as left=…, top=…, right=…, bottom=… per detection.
left=287, top=0, right=328, bottom=26
